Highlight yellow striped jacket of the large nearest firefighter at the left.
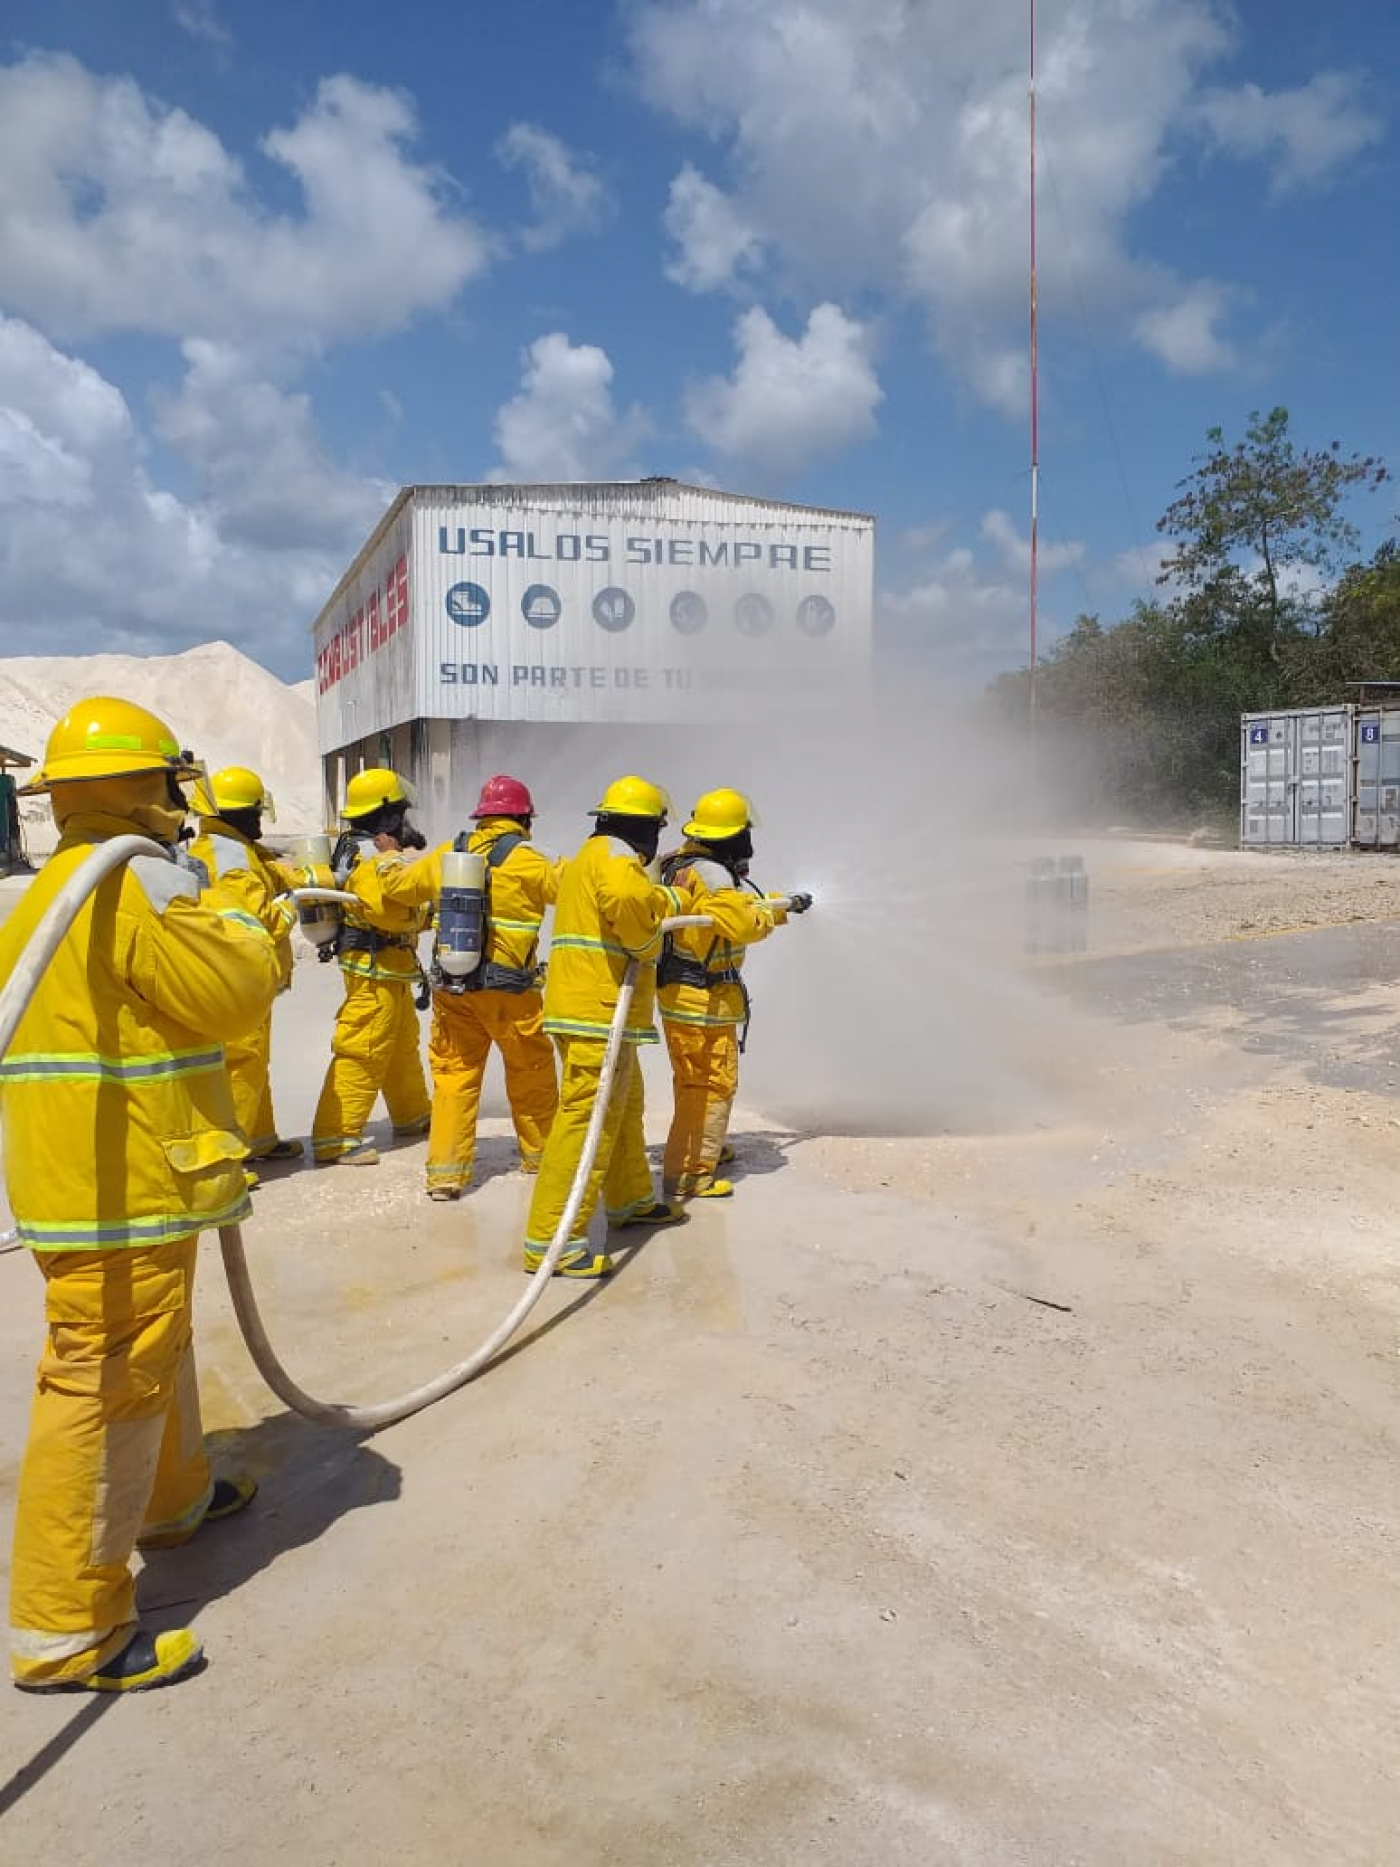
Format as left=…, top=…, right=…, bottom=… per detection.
left=0, top=812, right=280, bottom=1251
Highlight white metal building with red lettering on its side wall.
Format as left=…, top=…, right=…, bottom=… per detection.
left=314, top=480, right=875, bottom=825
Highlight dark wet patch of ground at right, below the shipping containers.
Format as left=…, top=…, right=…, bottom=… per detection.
left=1045, top=920, right=1400, bottom=1094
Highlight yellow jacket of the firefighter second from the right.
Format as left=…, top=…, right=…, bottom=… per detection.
left=545, top=836, right=689, bottom=1044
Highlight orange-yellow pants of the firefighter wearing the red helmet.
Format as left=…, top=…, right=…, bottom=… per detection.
left=427, top=991, right=558, bottom=1187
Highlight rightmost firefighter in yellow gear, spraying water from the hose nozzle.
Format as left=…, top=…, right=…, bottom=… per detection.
left=657, top=790, right=812, bottom=1200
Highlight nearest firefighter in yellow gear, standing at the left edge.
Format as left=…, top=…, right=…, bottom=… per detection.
left=0, top=698, right=280, bottom=1692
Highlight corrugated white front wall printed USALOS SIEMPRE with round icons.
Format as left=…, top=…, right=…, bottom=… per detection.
left=413, top=484, right=874, bottom=723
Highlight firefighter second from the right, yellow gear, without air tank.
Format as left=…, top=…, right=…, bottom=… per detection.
left=525, top=777, right=691, bottom=1277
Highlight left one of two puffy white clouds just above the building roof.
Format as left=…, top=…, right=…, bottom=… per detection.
left=489, top=330, right=650, bottom=484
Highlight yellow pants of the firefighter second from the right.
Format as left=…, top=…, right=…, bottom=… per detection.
left=525, top=1038, right=655, bottom=1251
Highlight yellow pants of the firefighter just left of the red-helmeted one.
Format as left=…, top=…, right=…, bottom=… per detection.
left=312, top=973, right=427, bottom=1161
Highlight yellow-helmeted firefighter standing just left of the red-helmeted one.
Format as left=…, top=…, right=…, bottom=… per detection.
left=312, top=767, right=429, bottom=1167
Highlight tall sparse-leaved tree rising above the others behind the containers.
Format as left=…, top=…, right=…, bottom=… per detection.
left=1157, top=409, right=1387, bottom=664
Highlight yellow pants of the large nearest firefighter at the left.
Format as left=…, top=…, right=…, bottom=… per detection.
left=9, top=1236, right=213, bottom=1684
